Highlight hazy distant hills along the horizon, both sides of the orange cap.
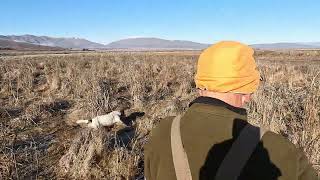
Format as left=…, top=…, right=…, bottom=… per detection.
left=0, top=35, right=320, bottom=50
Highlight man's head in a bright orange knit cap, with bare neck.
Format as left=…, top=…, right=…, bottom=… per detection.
left=195, top=41, right=260, bottom=107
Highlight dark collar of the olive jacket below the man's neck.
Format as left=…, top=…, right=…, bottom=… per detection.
left=189, top=96, right=247, bottom=115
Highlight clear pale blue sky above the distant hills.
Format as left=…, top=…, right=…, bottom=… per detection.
left=0, top=0, right=320, bottom=44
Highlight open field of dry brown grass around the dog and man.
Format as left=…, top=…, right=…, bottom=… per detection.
left=0, top=50, right=320, bottom=179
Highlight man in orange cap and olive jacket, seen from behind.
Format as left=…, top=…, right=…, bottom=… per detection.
left=145, top=42, right=317, bottom=180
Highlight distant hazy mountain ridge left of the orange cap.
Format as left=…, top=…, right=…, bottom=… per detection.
left=0, top=35, right=209, bottom=49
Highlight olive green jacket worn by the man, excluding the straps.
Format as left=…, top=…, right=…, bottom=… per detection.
left=144, top=97, right=318, bottom=180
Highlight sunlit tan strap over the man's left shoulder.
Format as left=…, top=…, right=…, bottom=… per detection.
left=171, top=116, right=192, bottom=180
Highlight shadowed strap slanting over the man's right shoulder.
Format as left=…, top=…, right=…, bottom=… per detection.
left=215, top=124, right=266, bottom=180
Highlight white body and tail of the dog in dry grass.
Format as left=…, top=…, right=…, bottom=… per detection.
left=76, top=111, right=122, bottom=129
